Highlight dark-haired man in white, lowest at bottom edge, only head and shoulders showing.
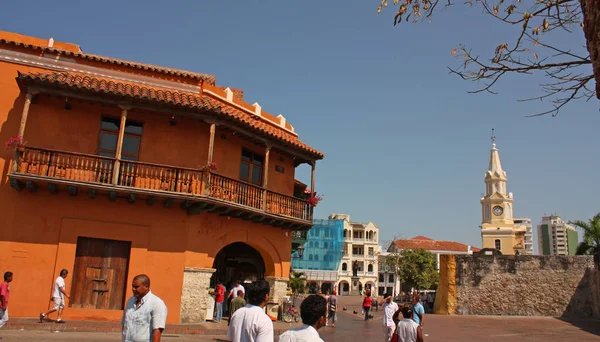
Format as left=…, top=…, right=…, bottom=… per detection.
left=279, top=295, right=327, bottom=342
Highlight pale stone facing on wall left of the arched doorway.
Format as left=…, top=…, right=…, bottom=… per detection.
left=179, top=267, right=215, bottom=323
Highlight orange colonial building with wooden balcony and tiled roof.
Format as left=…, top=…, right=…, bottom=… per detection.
left=0, top=31, right=323, bottom=323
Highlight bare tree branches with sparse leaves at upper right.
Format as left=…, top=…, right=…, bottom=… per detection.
left=378, top=0, right=600, bottom=117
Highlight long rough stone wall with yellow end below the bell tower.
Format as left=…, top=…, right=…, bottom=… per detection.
left=435, top=255, right=600, bottom=317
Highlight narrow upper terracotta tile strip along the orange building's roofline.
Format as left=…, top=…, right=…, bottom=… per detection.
left=0, top=39, right=215, bottom=85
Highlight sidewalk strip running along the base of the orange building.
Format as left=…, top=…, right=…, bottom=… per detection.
left=3, top=318, right=302, bottom=335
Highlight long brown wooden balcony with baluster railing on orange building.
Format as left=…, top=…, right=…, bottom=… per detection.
left=9, top=147, right=313, bottom=230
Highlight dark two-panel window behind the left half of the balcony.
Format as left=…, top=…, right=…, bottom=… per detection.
left=98, top=117, right=143, bottom=160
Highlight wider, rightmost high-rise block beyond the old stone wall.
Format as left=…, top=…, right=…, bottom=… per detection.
left=538, top=215, right=579, bottom=255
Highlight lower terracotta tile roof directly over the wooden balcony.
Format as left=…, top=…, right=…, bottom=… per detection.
left=17, top=72, right=324, bottom=159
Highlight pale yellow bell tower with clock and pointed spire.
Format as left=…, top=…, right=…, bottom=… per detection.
left=481, top=129, right=525, bottom=255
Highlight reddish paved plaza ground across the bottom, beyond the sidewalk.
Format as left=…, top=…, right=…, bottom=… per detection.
left=0, top=297, right=600, bottom=342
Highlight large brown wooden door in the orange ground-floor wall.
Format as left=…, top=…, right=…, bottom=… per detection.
left=69, top=237, right=131, bottom=310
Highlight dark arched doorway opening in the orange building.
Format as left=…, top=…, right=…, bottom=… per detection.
left=211, top=242, right=265, bottom=288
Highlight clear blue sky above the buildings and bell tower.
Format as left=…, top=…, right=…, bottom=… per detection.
left=0, top=0, right=600, bottom=251
